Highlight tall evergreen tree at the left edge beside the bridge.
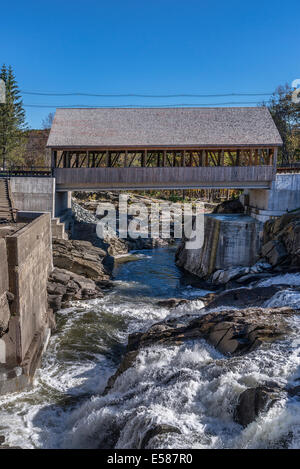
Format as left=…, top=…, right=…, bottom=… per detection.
left=0, top=65, right=27, bottom=169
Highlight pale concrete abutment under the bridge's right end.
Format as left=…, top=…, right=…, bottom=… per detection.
left=242, top=174, right=300, bottom=222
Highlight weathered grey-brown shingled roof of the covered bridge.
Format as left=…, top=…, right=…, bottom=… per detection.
left=47, top=107, right=282, bottom=148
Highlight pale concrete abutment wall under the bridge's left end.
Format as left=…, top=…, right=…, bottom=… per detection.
left=10, top=177, right=55, bottom=217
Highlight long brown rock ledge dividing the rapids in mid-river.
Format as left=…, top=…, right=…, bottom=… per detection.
left=106, top=307, right=297, bottom=392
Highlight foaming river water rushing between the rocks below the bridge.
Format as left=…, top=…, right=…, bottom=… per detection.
left=0, top=248, right=300, bottom=448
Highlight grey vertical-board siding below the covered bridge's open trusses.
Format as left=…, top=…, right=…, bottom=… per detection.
left=54, top=166, right=275, bottom=189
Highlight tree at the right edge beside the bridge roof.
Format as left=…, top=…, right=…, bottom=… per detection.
left=266, top=85, right=300, bottom=164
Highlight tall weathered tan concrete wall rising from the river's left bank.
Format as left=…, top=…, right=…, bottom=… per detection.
left=3, top=214, right=52, bottom=373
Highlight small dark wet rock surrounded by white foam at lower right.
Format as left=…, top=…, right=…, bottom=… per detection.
left=234, top=385, right=281, bottom=427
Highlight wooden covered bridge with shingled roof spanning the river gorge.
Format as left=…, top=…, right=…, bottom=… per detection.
left=47, top=107, right=282, bottom=191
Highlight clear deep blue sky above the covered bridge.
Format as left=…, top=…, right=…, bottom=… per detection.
left=0, top=0, right=300, bottom=128
